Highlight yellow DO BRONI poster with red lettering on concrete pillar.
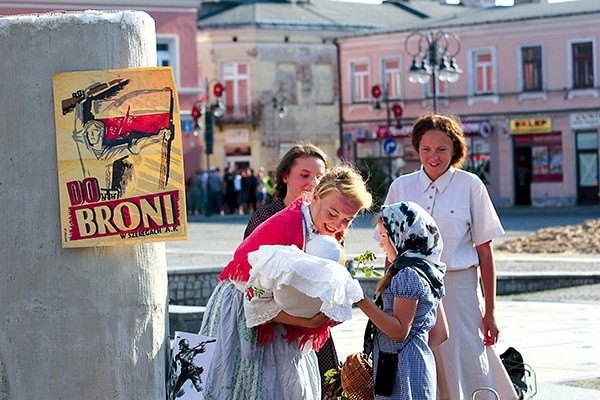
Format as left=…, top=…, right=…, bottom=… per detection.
left=53, top=67, right=187, bottom=247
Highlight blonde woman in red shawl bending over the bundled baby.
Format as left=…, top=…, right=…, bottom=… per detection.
left=200, top=166, right=372, bottom=400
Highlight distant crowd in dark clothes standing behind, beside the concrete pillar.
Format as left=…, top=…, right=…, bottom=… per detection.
left=186, top=165, right=275, bottom=215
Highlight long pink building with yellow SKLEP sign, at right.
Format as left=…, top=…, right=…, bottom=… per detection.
left=336, top=0, right=600, bottom=207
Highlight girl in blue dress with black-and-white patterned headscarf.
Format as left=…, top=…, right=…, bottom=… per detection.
left=357, top=201, right=448, bottom=400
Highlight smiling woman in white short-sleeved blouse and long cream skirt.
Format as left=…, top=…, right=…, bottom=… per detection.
left=385, top=115, right=517, bottom=400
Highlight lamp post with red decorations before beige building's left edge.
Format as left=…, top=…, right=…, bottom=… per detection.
left=192, top=79, right=225, bottom=170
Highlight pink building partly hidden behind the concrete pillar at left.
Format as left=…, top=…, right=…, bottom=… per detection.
left=0, top=0, right=204, bottom=182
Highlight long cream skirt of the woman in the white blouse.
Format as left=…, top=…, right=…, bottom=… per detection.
left=434, top=267, right=518, bottom=400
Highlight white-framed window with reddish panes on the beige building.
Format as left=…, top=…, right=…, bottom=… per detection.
left=222, top=62, right=250, bottom=117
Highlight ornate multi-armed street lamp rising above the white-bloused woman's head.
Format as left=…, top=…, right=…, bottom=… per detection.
left=404, top=30, right=462, bottom=114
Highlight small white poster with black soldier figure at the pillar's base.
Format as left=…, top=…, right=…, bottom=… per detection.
left=167, top=331, right=217, bottom=400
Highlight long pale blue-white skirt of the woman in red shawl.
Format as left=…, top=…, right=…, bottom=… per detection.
left=200, top=281, right=321, bottom=400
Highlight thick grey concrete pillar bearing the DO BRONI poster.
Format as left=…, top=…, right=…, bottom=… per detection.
left=0, top=11, right=168, bottom=400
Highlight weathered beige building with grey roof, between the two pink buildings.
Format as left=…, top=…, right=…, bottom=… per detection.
left=192, top=0, right=464, bottom=173
